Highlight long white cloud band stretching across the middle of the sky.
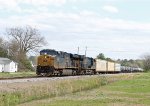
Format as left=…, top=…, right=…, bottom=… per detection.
left=1, top=8, right=150, bottom=33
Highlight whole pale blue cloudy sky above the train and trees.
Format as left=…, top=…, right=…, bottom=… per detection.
left=0, top=0, right=150, bottom=59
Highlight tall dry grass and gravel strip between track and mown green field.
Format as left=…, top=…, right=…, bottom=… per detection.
left=0, top=77, right=102, bottom=106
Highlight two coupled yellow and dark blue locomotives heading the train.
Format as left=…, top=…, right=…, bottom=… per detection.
left=36, top=49, right=95, bottom=76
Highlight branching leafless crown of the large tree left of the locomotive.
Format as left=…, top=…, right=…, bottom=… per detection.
left=6, top=26, right=45, bottom=55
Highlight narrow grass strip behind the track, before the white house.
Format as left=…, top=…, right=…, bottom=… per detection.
left=0, top=71, right=36, bottom=78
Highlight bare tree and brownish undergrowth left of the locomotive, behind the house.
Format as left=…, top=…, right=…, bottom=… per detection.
left=0, top=26, right=46, bottom=70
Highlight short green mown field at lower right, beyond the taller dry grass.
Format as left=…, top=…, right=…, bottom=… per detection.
left=20, top=73, right=150, bottom=106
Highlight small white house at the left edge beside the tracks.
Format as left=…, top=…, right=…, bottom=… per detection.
left=0, top=57, right=18, bottom=72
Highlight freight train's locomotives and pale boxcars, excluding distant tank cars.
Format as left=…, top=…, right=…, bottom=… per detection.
left=36, top=49, right=143, bottom=76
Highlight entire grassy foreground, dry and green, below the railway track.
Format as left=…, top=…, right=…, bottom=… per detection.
left=0, top=73, right=150, bottom=106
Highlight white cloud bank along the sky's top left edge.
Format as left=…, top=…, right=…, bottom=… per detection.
left=0, top=0, right=86, bottom=13
